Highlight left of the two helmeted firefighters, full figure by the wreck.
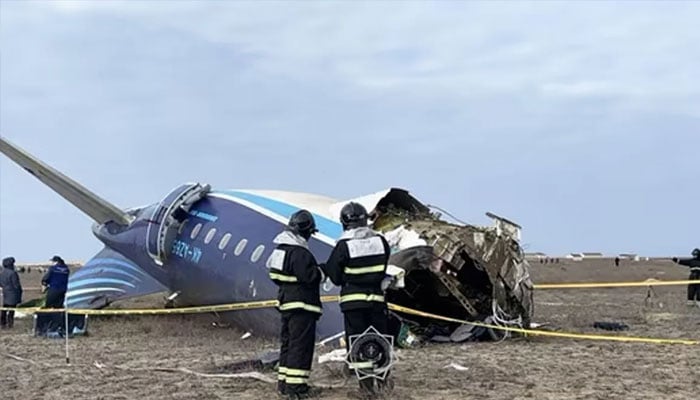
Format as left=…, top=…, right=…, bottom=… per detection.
left=268, top=210, right=325, bottom=399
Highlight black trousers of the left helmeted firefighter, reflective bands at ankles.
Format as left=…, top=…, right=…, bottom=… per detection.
left=277, top=310, right=318, bottom=394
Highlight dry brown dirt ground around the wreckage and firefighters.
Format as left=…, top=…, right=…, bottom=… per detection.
left=0, top=260, right=700, bottom=400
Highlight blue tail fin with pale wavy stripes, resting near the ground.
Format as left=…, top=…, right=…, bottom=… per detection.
left=66, top=247, right=168, bottom=309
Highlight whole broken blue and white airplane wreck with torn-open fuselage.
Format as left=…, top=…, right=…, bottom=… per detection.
left=0, top=138, right=534, bottom=345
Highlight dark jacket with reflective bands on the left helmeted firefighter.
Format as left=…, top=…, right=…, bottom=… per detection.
left=267, top=231, right=323, bottom=316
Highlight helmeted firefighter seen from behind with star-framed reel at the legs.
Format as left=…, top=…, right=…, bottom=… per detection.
left=323, top=202, right=391, bottom=393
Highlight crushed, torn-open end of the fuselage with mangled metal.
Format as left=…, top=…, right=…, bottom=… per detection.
left=364, top=191, right=534, bottom=341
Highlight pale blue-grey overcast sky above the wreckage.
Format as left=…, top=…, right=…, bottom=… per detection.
left=0, top=1, right=700, bottom=261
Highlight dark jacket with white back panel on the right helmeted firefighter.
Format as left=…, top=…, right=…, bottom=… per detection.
left=323, top=227, right=391, bottom=311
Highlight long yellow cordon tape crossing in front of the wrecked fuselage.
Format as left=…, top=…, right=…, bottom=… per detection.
left=0, top=296, right=700, bottom=345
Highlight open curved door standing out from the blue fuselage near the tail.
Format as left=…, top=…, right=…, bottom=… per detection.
left=146, top=183, right=211, bottom=265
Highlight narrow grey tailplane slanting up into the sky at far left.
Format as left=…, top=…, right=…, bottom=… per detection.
left=0, top=137, right=132, bottom=225
